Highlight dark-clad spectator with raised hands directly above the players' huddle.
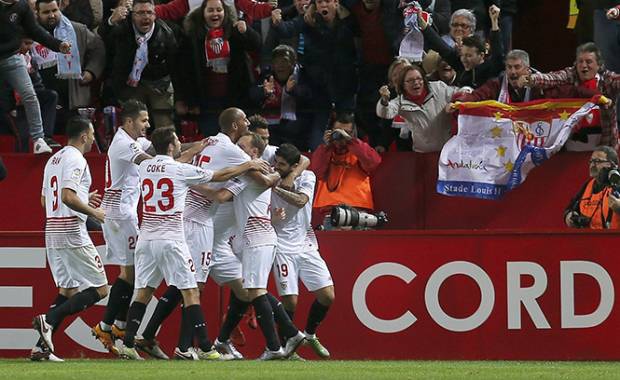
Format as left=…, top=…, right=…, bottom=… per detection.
left=250, top=45, right=312, bottom=151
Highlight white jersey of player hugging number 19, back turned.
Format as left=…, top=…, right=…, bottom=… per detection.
left=226, top=175, right=277, bottom=249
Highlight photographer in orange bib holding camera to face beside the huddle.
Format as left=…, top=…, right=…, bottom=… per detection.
left=310, top=114, right=381, bottom=214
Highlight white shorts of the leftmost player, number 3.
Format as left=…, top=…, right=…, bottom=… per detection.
left=45, top=245, right=108, bottom=289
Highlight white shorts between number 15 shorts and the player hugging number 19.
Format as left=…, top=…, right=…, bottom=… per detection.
left=206, top=219, right=243, bottom=286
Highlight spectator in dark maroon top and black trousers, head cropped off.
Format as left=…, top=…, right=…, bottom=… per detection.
left=351, top=0, right=404, bottom=147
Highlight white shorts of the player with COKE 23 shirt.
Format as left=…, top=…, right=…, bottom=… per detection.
left=135, top=240, right=197, bottom=289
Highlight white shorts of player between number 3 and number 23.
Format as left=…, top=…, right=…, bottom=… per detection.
left=101, top=219, right=139, bottom=266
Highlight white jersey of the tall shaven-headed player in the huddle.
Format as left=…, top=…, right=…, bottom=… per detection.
left=183, top=132, right=250, bottom=224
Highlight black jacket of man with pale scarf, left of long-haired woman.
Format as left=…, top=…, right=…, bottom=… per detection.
left=99, top=16, right=179, bottom=94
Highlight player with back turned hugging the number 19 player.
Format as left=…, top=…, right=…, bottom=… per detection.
left=211, top=132, right=305, bottom=360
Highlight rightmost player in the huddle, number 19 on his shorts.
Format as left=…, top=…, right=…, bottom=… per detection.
left=271, top=144, right=335, bottom=358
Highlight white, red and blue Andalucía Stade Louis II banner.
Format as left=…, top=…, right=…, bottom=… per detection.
left=437, top=99, right=597, bottom=199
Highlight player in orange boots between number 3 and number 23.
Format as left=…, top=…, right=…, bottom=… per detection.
left=92, top=100, right=201, bottom=359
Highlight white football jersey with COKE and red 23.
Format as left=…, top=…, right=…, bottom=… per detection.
left=138, top=155, right=213, bottom=241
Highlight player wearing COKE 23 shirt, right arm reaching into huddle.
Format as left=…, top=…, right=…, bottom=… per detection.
left=119, top=128, right=262, bottom=360
